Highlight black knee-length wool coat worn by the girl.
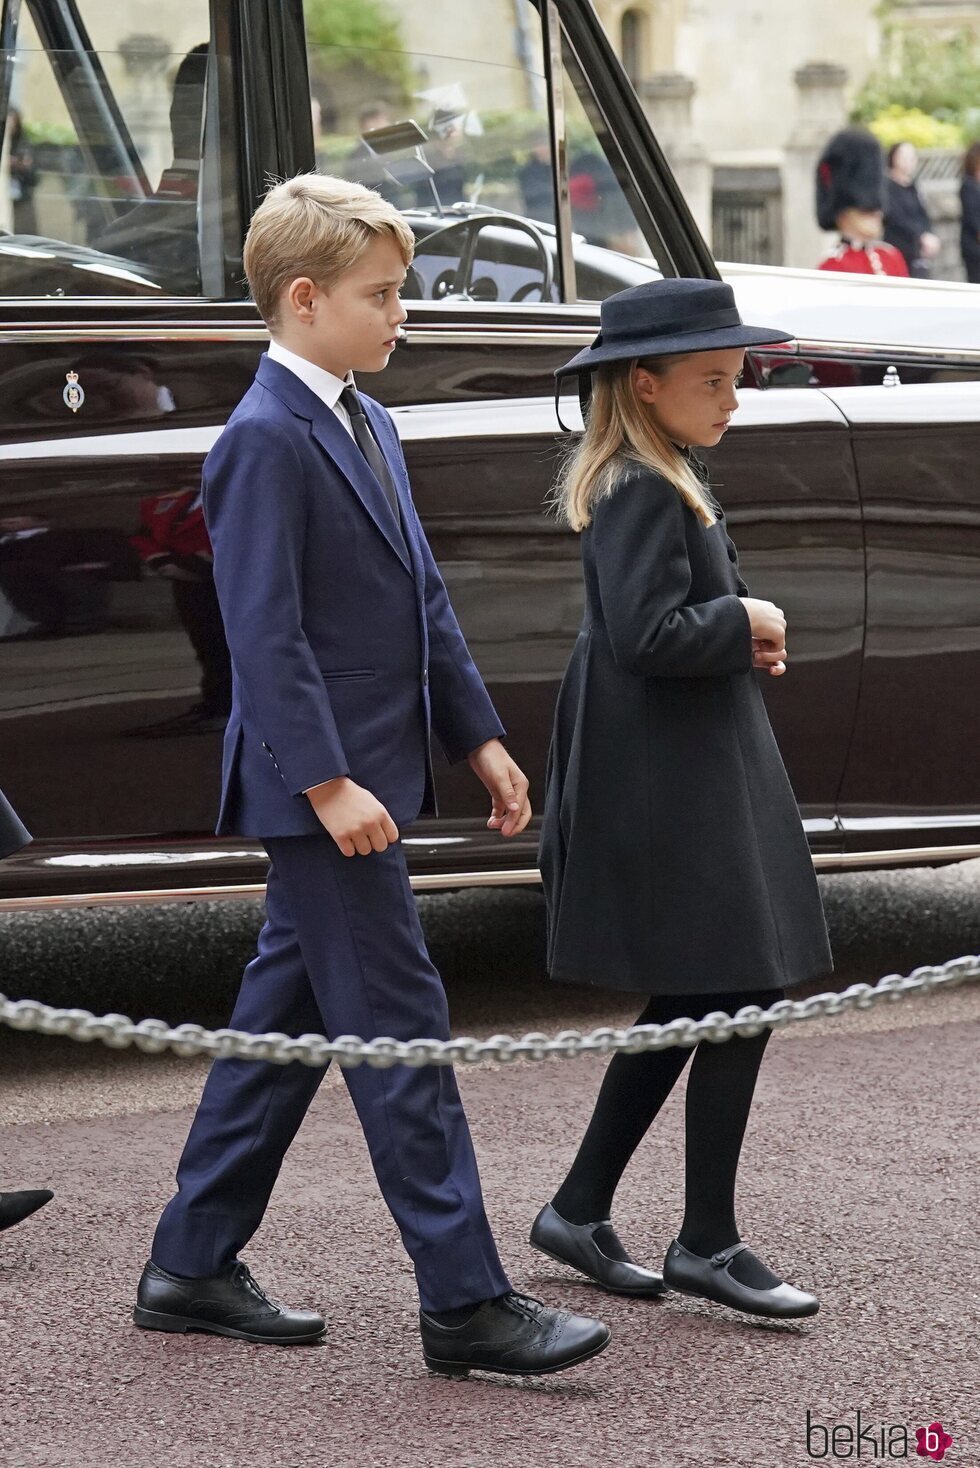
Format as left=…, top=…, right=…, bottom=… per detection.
left=538, top=467, right=833, bottom=995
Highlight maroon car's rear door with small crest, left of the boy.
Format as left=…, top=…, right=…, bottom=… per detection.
left=0, top=0, right=275, bottom=890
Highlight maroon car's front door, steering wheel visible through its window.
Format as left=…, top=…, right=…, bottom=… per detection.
left=296, top=3, right=864, bottom=878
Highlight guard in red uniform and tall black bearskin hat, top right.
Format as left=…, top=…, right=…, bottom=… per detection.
left=817, top=128, right=908, bottom=276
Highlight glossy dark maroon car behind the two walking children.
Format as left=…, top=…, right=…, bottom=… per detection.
left=0, top=0, right=980, bottom=906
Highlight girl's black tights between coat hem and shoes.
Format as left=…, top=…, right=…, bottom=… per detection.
left=552, top=989, right=783, bottom=1289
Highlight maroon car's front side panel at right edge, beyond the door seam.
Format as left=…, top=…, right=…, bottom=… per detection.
left=827, top=367, right=980, bottom=860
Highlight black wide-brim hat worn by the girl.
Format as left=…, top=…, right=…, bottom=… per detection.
left=555, top=279, right=792, bottom=379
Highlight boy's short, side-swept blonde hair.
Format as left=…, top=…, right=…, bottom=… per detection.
left=244, top=173, right=415, bottom=326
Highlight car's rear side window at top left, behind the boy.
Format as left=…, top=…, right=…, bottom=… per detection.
left=0, top=0, right=231, bottom=297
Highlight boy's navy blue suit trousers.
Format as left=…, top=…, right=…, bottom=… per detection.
left=153, top=832, right=511, bottom=1311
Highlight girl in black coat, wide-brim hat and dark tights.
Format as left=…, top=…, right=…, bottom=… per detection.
left=531, top=280, right=832, bottom=1317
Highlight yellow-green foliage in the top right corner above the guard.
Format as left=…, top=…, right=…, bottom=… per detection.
left=851, top=4, right=980, bottom=137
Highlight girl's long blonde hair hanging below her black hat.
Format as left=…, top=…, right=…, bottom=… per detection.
left=552, top=357, right=717, bottom=530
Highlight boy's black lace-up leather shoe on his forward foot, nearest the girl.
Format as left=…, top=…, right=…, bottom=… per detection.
left=418, top=1290, right=609, bottom=1377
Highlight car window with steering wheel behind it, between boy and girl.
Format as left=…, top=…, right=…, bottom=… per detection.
left=305, top=0, right=663, bottom=302
